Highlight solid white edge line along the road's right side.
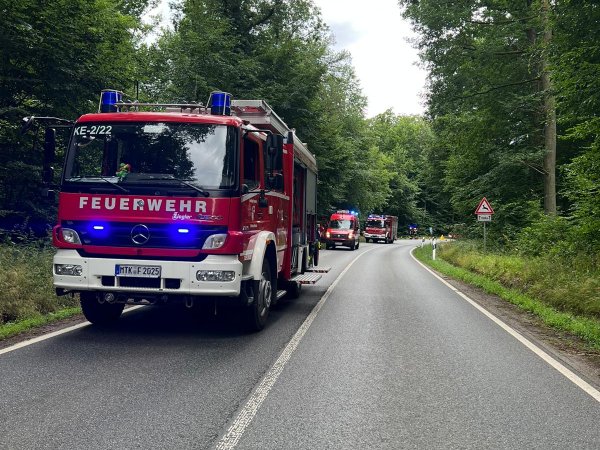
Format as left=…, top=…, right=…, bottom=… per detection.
left=410, top=248, right=600, bottom=402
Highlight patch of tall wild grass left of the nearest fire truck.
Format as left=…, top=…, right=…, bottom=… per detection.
left=0, top=241, right=80, bottom=339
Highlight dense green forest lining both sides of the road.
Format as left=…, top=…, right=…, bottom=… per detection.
left=0, top=0, right=600, bottom=265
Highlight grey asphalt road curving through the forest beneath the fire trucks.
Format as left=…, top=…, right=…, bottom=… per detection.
left=0, top=241, right=600, bottom=449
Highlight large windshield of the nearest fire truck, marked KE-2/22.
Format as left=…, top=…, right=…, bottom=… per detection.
left=64, top=122, right=236, bottom=192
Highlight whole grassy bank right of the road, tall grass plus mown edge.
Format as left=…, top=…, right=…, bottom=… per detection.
left=414, top=243, right=600, bottom=349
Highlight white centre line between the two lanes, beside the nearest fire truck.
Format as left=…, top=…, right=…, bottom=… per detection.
left=216, top=247, right=383, bottom=450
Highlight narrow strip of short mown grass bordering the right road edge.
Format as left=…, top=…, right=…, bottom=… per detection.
left=414, top=245, right=600, bottom=350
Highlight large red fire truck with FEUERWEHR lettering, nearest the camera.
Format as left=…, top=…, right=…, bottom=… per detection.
left=36, top=90, right=324, bottom=330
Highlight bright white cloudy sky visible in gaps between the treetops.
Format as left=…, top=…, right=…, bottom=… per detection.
left=146, top=0, right=426, bottom=117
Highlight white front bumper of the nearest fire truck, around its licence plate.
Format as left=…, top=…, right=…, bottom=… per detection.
left=52, top=249, right=242, bottom=297
